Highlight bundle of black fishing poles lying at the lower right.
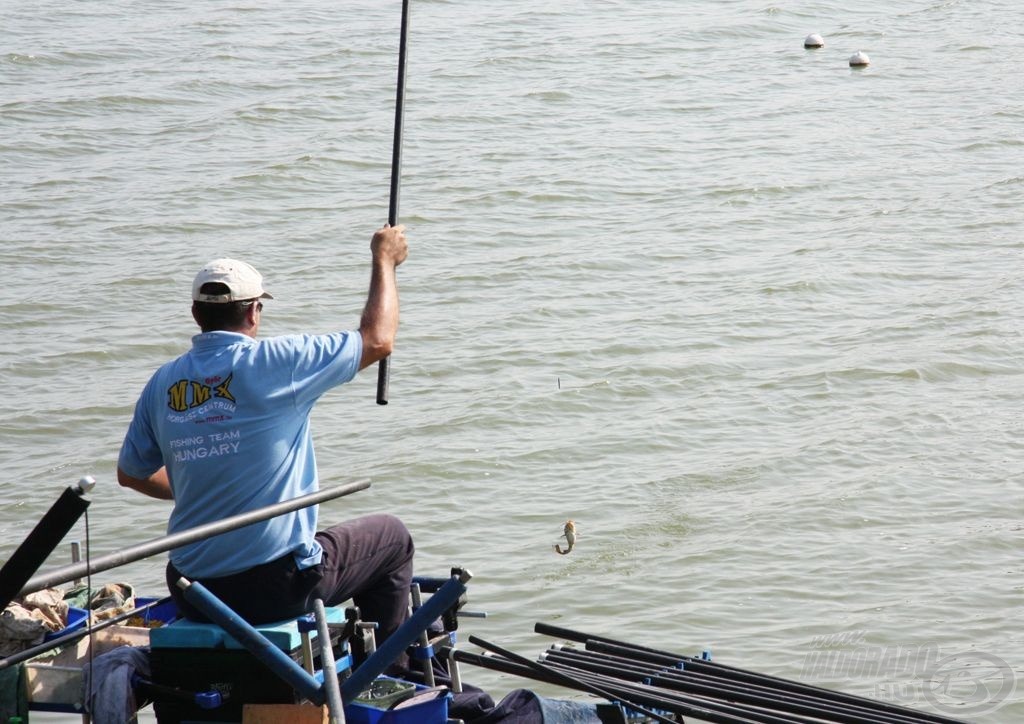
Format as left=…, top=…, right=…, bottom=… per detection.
left=454, top=623, right=964, bottom=724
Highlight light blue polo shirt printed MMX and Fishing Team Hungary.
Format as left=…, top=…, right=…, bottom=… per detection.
left=118, top=332, right=362, bottom=579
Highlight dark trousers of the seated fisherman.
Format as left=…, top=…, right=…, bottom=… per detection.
left=167, top=515, right=414, bottom=642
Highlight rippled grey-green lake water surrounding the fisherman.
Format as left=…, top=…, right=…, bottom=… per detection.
left=0, top=0, right=1024, bottom=722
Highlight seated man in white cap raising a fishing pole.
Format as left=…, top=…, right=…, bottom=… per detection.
left=118, top=226, right=413, bottom=640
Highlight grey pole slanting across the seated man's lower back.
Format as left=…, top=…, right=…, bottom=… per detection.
left=17, top=480, right=370, bottom=596
